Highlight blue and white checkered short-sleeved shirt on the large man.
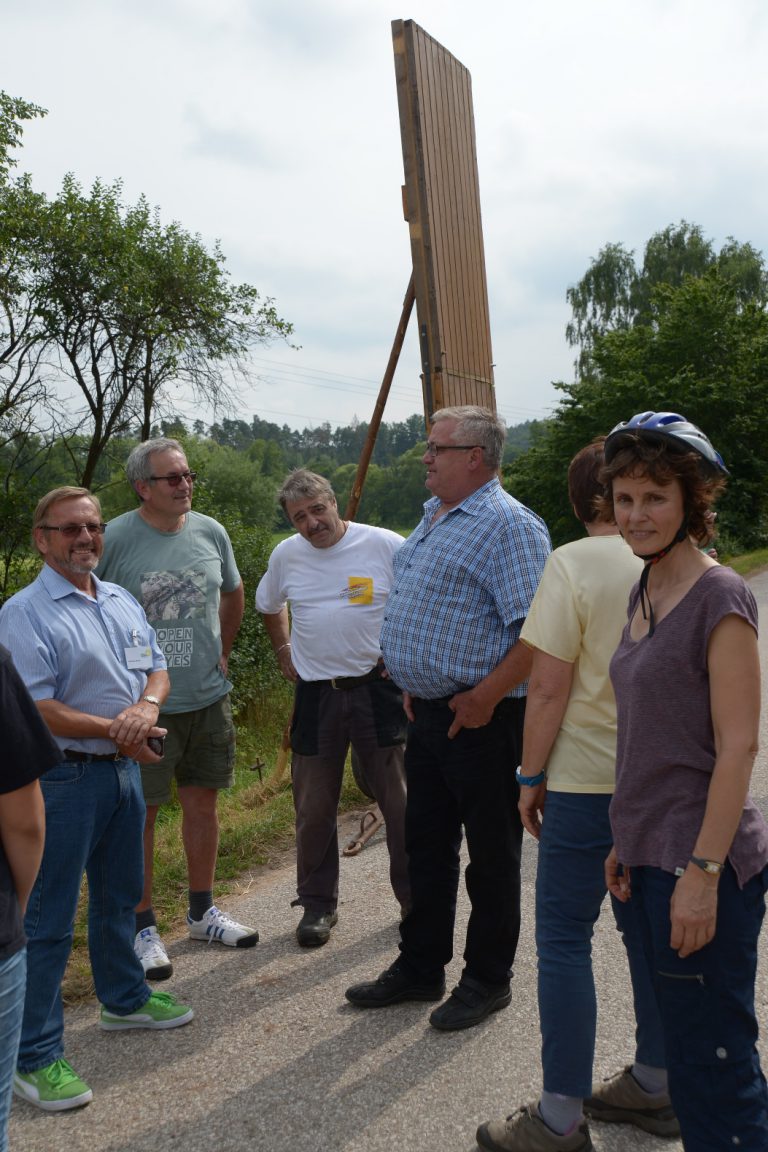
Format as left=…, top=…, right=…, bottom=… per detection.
left=381, top=479, right=552, bottom=699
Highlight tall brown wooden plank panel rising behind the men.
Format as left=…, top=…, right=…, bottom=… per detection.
left=391, top=20, right=496, bottom=424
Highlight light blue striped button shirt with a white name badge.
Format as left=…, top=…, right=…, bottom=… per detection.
left=0, top=564, right=166, bottom=752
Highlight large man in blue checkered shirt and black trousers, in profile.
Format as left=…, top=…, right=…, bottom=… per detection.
left=347, top=406, right=550, bottom=1031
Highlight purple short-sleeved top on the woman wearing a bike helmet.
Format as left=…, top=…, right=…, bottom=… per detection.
left=610, top=567, right=768, bottom=886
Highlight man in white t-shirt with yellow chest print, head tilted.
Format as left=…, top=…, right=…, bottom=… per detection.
left=256, top=469, right=410, bottom=947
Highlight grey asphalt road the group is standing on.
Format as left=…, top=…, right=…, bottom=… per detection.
left=10, top=574, right=768, bottom=1152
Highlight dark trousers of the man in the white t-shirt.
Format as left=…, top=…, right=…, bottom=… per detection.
left=291, top=680, right=411, bottom=912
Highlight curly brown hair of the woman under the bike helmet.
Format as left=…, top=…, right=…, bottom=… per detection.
left=596, top=432, right=725, bottom=544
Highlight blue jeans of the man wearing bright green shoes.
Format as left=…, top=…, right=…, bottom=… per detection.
left=18, top=759, right=150, bottom=1073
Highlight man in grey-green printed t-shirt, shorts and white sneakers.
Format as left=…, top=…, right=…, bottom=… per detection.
left=99, top=438, right=259, bottom=980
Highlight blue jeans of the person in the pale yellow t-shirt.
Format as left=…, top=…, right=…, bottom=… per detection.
left=535, top=791, right=666, bottom=1099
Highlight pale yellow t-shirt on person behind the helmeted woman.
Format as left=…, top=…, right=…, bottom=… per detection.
left=520, top=536, right=642, bottom=793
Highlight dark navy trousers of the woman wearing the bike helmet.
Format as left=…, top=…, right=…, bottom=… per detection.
left=632, top=864, right=768, bottom=1152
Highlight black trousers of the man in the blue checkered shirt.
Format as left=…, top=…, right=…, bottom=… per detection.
left=400, top=698, right=525, bottom=984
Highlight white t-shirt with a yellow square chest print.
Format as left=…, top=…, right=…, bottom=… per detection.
left=256, top=522, right=403, bottom=680
